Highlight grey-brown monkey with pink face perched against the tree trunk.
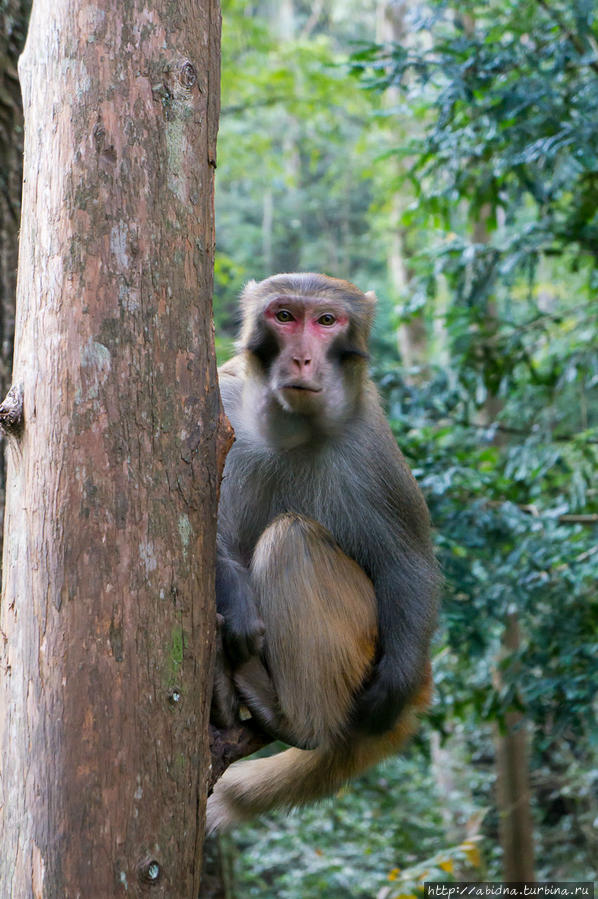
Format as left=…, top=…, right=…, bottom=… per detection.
left=207, top=273, right=440, bottom=832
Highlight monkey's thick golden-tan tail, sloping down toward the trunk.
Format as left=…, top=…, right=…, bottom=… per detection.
left=206, top=702, right=424, bottom=833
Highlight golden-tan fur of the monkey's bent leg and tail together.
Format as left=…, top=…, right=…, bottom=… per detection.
left=207, top=514, right=430, bottom=831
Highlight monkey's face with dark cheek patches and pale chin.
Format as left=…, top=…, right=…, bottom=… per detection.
left=261, top=295, right=364, bottom=421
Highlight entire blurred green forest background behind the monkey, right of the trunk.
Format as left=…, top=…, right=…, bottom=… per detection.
left=215, top=0, right=598, bottom=899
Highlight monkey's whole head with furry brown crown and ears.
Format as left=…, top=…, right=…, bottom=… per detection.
left=240, top=273, right=376, bottom=426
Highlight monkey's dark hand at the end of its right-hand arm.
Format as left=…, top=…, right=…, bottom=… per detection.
left=352, top=656, right=417, bottom=735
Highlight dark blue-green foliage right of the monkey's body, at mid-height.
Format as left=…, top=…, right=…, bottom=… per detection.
left=382, top=356, right=598, bottom=741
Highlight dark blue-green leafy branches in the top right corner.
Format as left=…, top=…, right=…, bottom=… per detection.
left=354, top=0, right=598, bottom=268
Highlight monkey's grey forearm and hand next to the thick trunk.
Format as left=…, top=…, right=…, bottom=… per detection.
left=216, top=538, right=264, bottom=665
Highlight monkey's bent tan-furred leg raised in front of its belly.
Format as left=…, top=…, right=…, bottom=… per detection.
left=239, top=514, right=377, bottom=747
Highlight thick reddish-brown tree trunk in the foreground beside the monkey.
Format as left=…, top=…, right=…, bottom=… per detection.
left=0, top=0, right=227, bottom=899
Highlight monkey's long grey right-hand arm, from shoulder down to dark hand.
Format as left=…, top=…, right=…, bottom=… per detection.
left=342, top=402, right=441, bottom=734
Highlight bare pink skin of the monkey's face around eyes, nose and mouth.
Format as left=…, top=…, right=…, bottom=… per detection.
left=264, top=296, right=349, bottom=393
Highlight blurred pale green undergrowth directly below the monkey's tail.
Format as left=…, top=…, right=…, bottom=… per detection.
left=230, top=752, right=482, bottom=899
